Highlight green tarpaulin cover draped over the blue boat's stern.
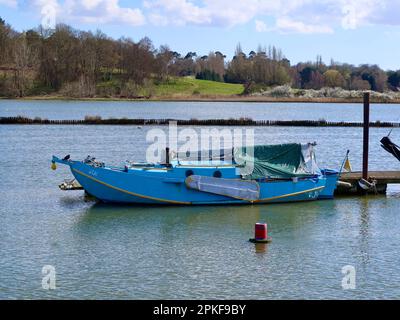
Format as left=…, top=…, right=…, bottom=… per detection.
left=234, top=143, right=315, bottom=179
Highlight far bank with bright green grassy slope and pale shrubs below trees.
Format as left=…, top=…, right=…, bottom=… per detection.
left=2, top=77, right=400, bottom=104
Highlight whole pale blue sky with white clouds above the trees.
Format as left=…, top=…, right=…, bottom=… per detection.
left=0, top=0, right=400, bottom=70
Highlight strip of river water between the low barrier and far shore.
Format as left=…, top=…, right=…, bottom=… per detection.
left=0, top=100, right=400, bottom=122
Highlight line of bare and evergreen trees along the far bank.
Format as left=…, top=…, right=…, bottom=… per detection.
left=0, top=18, right=400, bottom=97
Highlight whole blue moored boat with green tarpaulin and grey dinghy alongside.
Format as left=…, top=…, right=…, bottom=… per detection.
left=52, top=144, right=338, bottom=205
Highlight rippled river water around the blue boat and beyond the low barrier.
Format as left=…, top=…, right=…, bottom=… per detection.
left=0, top=101, right=400, bottom=299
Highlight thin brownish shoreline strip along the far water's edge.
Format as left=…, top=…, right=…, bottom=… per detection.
left=0, top=95, right=400, bottom=104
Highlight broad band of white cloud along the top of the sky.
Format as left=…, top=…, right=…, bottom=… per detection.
left=15, top=0, right=400, bottom=34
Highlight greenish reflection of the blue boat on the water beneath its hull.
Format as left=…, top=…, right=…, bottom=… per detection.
left=72, top=201, right=336, bottom=254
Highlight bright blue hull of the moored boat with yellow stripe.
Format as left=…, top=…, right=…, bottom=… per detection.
left=53, top=157, right=326, bottom=205
